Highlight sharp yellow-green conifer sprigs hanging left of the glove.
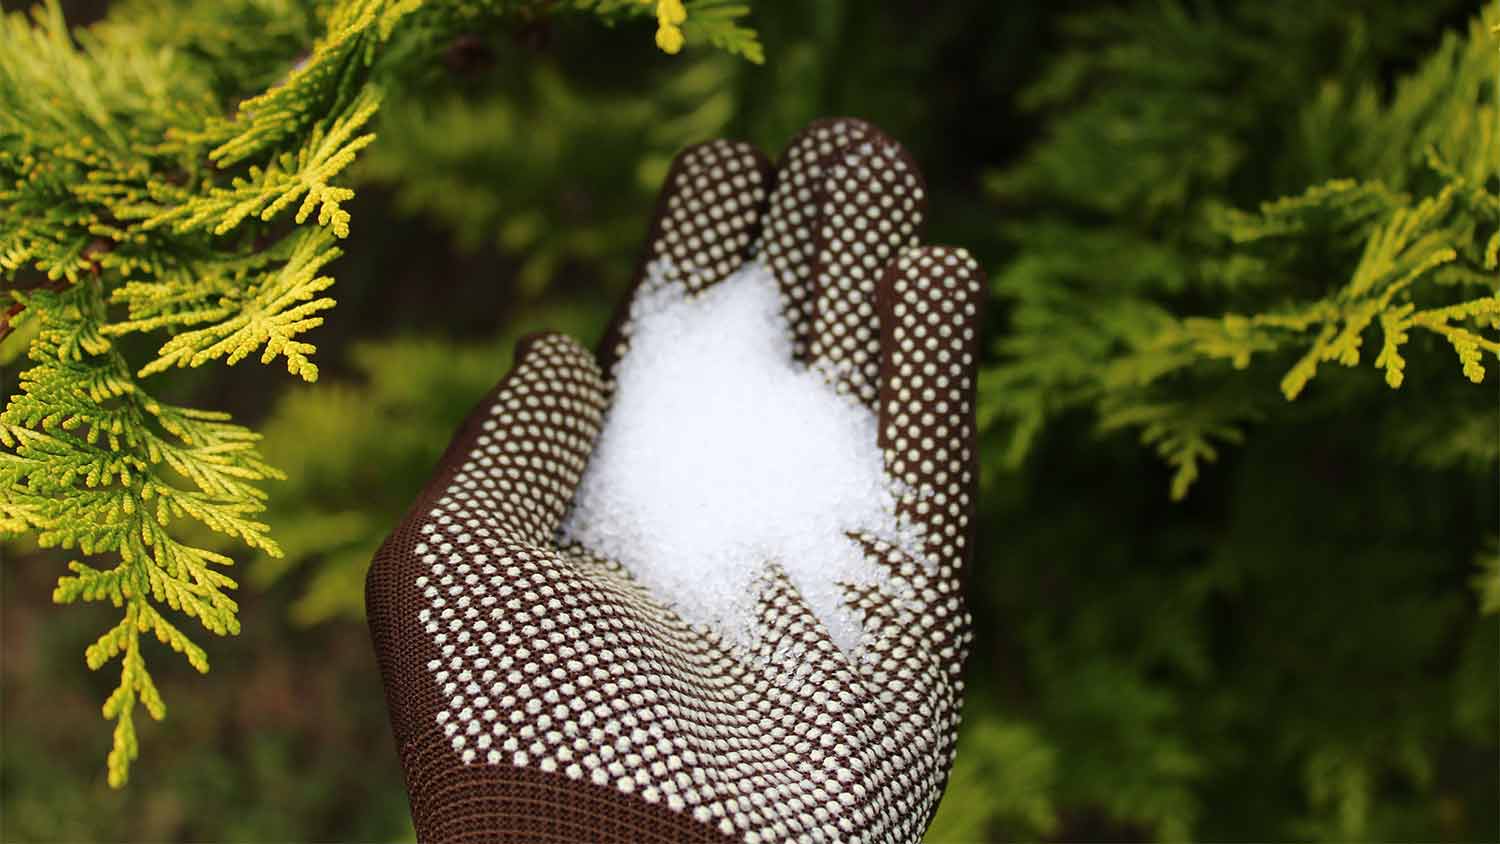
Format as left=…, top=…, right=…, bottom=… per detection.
left=0, top=0, right=759, bottom=786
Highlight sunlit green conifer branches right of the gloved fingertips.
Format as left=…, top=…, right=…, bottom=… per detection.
left=981, top=3, right=1500, bottom=498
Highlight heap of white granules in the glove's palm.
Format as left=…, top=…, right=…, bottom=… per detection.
left=563, top=262, right=911, bottom=654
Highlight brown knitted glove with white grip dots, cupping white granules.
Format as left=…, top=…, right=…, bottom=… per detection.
left=366, top=120, right=983, bottom=843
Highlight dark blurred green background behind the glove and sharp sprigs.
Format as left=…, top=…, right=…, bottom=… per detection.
left=0, top=0, right=1500, bottom=841
